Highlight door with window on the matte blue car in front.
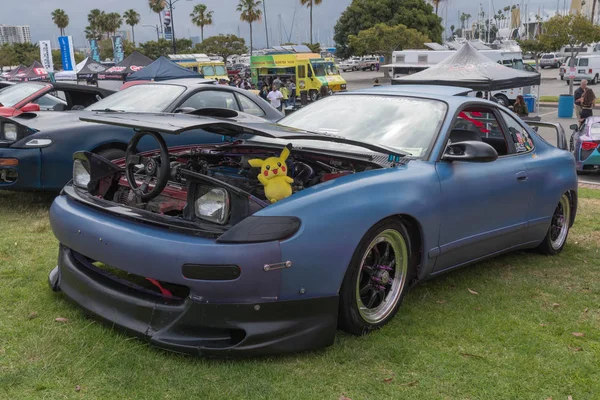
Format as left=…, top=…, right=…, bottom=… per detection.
left=435, top=106, right=530, bottom=271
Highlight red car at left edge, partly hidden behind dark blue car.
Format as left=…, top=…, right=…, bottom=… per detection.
left=0, top=82, right=114, bottom=117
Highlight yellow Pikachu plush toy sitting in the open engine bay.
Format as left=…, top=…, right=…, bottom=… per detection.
left=248, top=144, right=294, bottom=203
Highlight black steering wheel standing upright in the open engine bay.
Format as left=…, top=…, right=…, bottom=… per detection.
left=125, top=132, right=170, bottom=202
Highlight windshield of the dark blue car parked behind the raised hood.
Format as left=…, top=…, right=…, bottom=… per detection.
left=86, top=84, right=185, bottom=112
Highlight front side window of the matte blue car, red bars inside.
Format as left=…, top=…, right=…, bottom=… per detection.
left=449, top=107, right=510, bottom=157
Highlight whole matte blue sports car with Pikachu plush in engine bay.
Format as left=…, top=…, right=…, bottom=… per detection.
left=49, top=86, right=577, bottom=356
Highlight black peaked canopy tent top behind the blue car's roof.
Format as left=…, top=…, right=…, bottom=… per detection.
left=392, top=42, right=541, bottom=91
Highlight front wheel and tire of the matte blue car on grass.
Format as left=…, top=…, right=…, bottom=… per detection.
left=339, top=219, right=416, bottom=335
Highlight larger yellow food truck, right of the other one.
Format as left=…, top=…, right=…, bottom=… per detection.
left=250, top=46, right=346, bottom=101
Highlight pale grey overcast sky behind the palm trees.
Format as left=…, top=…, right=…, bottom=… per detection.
left=0, top=0, right=571, bottom=47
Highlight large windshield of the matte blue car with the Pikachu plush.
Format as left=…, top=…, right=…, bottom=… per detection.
left=278, top=95, right=447, bottom=157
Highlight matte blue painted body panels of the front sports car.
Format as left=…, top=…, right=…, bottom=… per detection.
left=50, top=91, right=577, bottom=301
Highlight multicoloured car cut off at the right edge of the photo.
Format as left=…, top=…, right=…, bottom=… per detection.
left=569, top=117, right=600, bottom=173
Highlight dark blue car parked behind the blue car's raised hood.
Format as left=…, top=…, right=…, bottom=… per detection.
left=0, top=79, right=283, bottom=191
